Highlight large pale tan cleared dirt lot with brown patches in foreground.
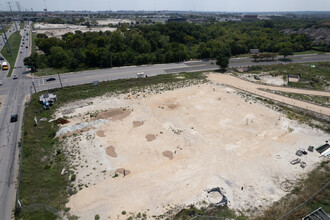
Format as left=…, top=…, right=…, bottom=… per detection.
left=56, top=74, right=327, bottom=219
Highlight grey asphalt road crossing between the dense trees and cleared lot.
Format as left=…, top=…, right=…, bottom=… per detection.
left=32, top=53, right=330, bottom=91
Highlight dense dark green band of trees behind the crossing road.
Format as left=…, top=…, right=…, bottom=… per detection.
left=25, top=21, right=312, bottom=71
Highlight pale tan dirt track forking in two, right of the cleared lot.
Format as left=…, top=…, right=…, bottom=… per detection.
left=209, top=73, right=330, bottom=116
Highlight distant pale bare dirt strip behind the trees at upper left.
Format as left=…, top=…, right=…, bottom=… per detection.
left=34, top=23, right=117, bottom=38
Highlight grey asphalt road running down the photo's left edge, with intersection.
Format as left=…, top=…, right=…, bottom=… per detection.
left=0, top=21, right=31, bottom=220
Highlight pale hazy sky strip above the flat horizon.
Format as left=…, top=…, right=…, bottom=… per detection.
left=0, top=0, right=330, bottom=12
